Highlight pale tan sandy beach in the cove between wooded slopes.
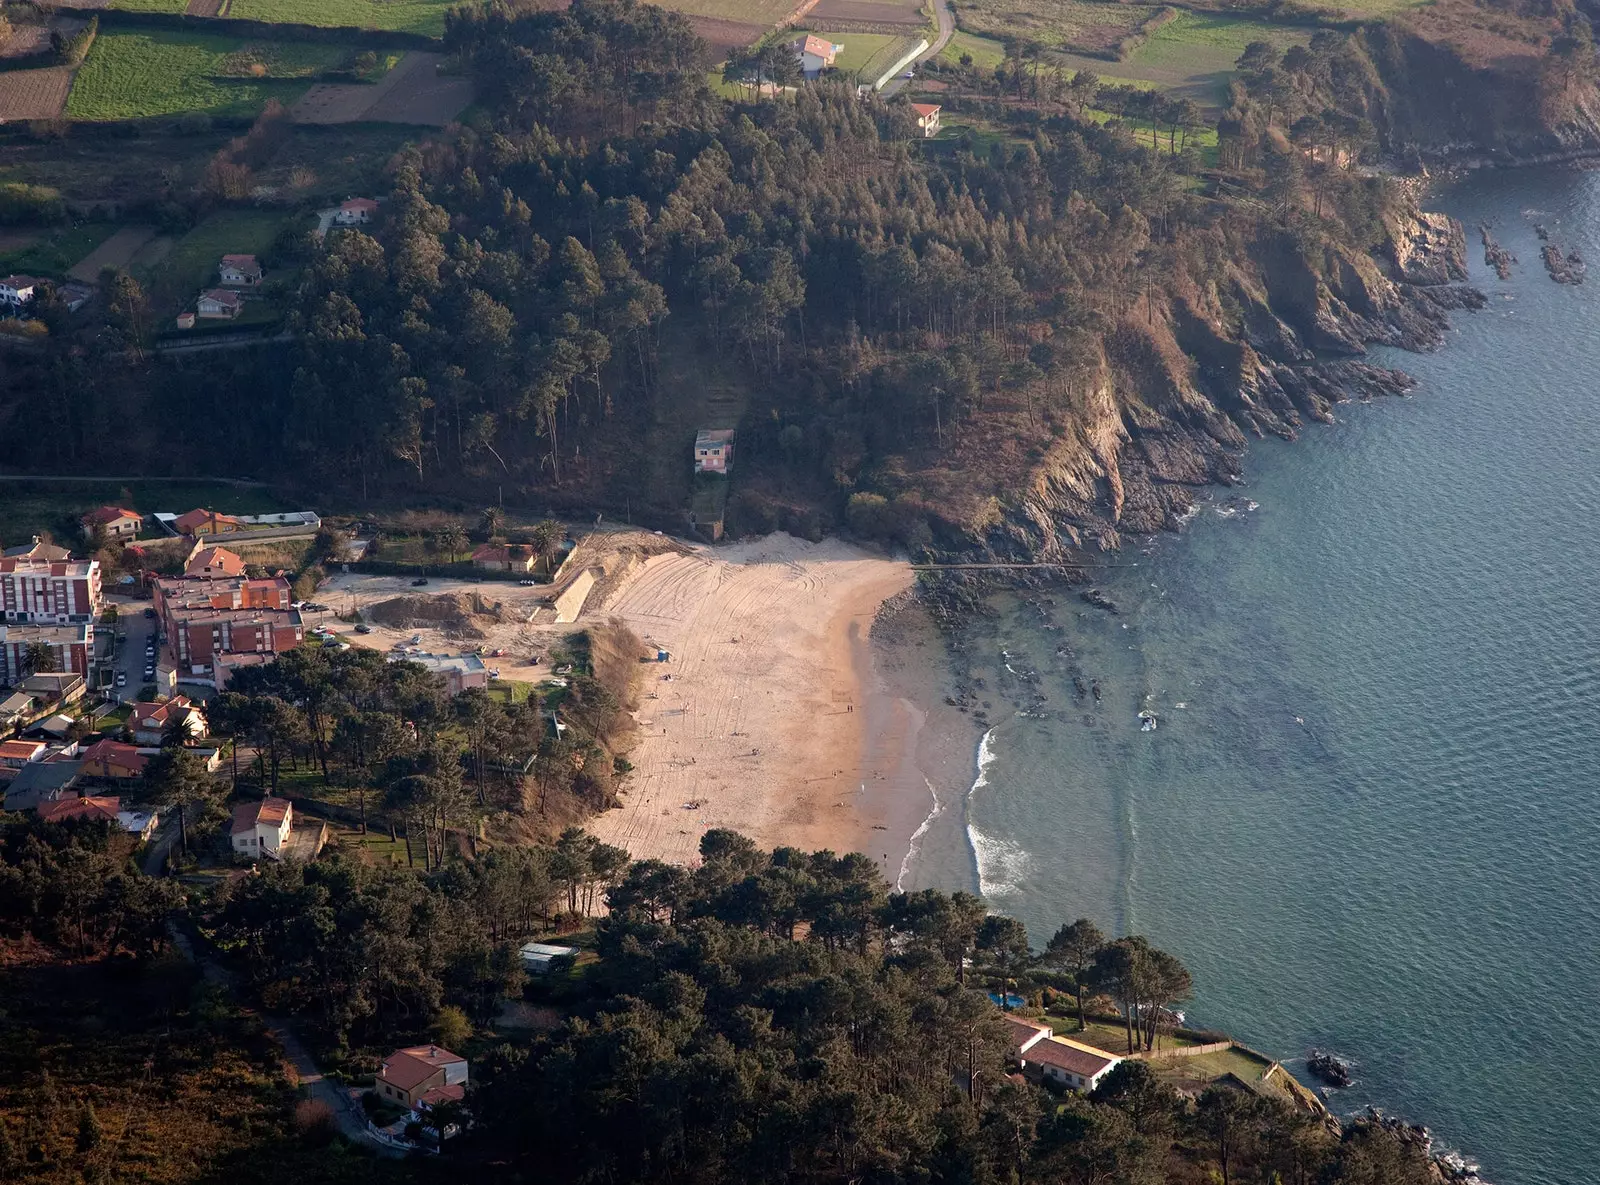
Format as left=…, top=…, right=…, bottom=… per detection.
left=586, top=534, right=930, bottom=880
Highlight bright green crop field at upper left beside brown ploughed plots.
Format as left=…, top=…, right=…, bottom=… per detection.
left=67, top=30, right=350, bottom=120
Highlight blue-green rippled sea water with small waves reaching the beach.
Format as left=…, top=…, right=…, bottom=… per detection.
left=917, top=171, right=1600, bottom=1185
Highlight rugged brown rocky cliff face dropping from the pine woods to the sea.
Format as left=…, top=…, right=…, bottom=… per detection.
left=968, top=211, right=1483, bottom=560
